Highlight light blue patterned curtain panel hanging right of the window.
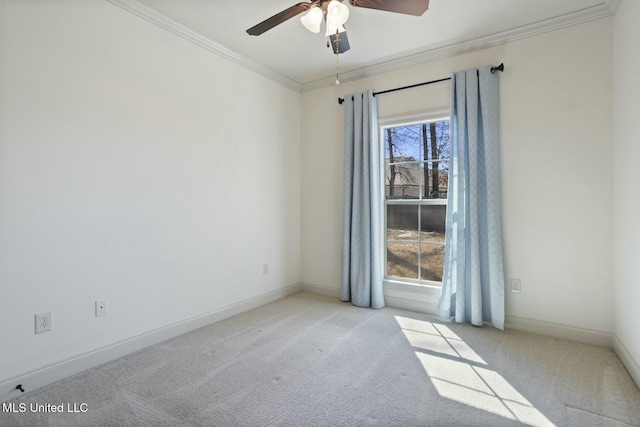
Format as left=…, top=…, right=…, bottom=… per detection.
left=438, top=66, right=504, bottom=329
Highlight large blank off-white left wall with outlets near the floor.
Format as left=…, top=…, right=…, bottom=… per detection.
left=0, top=0, right=300, bottom=384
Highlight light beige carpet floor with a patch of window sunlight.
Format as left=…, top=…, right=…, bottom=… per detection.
left=0, top=293, right=640, bottom=427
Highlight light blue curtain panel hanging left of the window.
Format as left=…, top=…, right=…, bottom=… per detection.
left=340, top=91, right=384, bottom=308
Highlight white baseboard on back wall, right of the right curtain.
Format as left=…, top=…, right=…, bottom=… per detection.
left=504, top=316, right=613, bottom=348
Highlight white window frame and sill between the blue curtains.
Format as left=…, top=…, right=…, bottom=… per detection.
left=378, top=111, right=450, bottom=292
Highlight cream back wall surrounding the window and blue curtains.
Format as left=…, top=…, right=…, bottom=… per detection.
left=302, top=19, right=613, bottom=332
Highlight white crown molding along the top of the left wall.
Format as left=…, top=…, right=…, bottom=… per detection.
left=107, top=0, right=301, bottom=92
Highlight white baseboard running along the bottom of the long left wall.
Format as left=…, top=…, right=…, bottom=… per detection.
left=0, top=283, right=303, bottom=402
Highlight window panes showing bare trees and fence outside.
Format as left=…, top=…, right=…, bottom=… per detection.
left=381, top=117, right=450, bottom=284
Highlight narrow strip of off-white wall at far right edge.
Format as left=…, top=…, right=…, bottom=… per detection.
left=613, top=0, right=640, bottom=384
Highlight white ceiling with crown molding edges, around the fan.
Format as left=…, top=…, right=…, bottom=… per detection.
left=108, top=0, right=620, bottom=90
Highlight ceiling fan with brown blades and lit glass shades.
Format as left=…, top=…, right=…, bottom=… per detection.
left=247, top=0, right=429, bottom=55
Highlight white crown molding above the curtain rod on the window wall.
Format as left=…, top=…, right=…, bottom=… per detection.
left=302, top=0, right=621, bottom=92
